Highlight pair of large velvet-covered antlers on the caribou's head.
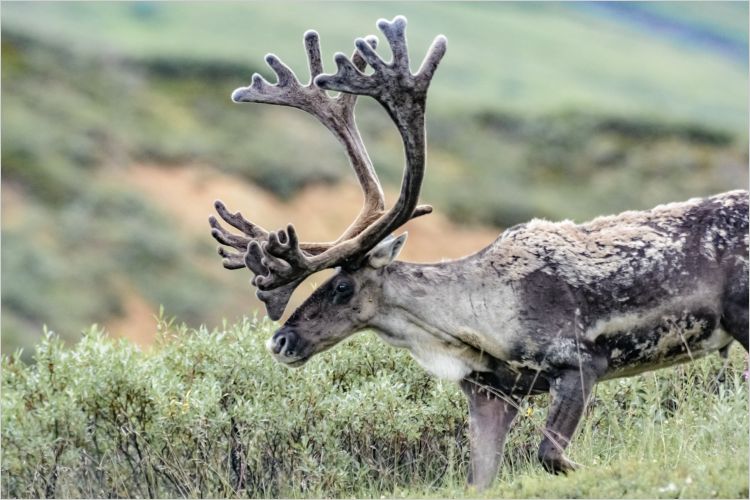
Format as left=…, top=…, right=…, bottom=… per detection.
left=209, top=16, right=446, bottom=319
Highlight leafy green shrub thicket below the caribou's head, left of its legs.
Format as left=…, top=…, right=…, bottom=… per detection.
left=2, top=320, right=465, bottom=497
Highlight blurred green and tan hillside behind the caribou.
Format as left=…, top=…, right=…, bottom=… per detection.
left=2, top=2, right=748, bottom=351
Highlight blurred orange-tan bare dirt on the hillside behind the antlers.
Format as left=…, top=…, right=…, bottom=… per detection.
left=107, top=165, right=506, bottom=344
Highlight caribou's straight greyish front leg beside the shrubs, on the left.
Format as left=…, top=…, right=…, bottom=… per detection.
left=461, top=379, right=518, bottom=490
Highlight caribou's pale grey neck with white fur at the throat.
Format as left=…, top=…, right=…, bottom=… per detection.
left=367, top=252, right=516, bottom=380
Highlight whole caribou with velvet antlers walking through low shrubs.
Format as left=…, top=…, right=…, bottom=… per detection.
left=209, top=16, right=748, bottom=489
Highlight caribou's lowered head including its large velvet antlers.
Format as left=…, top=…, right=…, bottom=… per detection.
left=210, top=16, right=446, bottom=366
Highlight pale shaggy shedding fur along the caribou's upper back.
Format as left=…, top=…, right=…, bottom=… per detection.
left=490, top=191, right=747, bottom=286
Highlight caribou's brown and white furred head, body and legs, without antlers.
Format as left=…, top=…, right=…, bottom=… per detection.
left=268, top=191, right=748, bottom=488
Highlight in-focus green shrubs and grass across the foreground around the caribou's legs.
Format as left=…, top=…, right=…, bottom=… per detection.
left=2, top=319, right=750, bottom=498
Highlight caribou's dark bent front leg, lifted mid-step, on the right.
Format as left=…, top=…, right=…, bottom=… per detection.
left=539, top=368, right=596, bottom=474
